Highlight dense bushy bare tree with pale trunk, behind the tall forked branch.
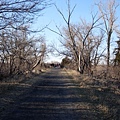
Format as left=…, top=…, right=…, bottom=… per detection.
left=63, top=18, right=104, bottom=73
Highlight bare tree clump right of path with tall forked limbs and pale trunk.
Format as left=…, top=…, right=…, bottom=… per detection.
left=49, top=0, right=101, bottom=74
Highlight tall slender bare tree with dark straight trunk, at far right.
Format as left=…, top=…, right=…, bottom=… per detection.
left=97, top=0, right=118, bottom=71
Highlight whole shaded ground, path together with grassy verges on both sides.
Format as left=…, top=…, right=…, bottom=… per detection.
left=0, top=68, right=120, bottom=120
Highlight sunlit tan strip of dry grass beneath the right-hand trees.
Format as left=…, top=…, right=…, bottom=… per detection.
left=66, top=70, right=120, bottom=95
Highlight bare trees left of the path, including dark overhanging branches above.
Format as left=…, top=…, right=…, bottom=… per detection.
left=0, top=0, right=48, bottom=78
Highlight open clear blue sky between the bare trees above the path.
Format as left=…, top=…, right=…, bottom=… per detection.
left=31, top=0, right=119, bottom=62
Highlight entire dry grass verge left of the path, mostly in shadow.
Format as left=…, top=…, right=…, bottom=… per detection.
left=0, top=70, right=48, bottom=114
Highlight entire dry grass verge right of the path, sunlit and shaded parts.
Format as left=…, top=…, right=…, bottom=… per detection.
left=66, top=70, right=120, bottom=120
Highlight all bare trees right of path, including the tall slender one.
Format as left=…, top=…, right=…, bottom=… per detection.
left=48, top=0, right=119, bottom=74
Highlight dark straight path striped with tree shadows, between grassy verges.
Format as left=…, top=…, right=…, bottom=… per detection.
left=0, top=69, right=119, bottom=120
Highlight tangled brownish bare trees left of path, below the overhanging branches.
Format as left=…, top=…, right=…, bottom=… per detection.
left=0, top=27, right=46, bottom=76
